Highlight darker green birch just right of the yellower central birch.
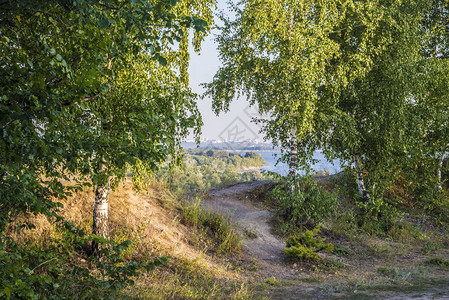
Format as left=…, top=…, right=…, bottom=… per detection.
left=323, top=1, right=430, bottom=215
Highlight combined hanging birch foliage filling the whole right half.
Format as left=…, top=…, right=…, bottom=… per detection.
left=206, top=0, right=449, bottom=230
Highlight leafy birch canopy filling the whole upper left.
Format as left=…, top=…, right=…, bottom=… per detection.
left=0, top=0, right=214, bottom=239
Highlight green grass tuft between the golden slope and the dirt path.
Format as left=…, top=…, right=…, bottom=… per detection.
left=182, top=199, right=242, bottom=253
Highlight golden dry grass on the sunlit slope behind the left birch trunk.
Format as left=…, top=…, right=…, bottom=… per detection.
left=9, top=181, right=250, bottom=299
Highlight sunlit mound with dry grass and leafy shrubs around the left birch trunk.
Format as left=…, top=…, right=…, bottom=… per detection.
left=0, top=180, right=248, bottom=299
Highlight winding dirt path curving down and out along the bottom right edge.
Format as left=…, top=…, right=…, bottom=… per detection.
left=203, top=181, right=449, bottom=299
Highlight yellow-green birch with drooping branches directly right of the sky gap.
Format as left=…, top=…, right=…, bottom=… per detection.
left=206, top=0, right=351, bottom=185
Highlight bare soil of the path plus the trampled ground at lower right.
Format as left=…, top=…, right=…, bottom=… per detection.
left=203, top=178, right=449, bottom=299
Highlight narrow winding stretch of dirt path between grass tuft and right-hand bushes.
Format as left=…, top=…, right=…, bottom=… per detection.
left=203, top=181, right=296, bottom=279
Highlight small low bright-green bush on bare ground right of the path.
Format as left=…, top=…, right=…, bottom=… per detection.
left=284, top=227, right=334, bottom=261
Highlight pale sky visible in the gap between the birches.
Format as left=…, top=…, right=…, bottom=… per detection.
left=185, top=0, right=263, bottom=142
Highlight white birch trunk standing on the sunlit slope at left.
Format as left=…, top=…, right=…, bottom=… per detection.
left=92, top=159, right=110, bottom=255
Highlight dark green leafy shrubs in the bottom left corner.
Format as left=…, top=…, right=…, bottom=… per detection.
left=0, top=223, right=168, bottom=299
